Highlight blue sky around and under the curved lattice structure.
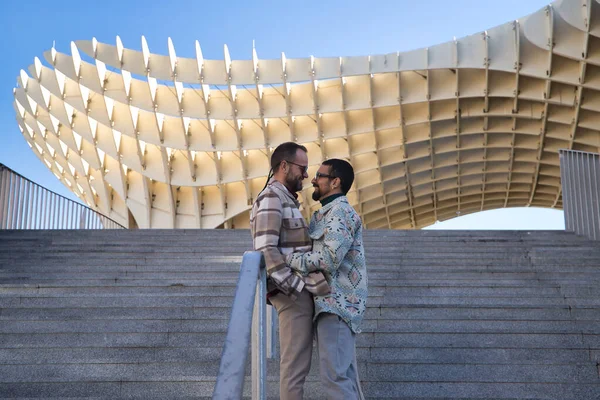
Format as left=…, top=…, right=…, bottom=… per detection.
left=0, top=0, right=564, bottom=229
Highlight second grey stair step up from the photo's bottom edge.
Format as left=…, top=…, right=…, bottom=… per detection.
left=0, top=361, right=598, bottom=385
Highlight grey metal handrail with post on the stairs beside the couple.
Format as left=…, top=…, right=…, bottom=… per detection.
left=212, top=251, right=277, bottom=400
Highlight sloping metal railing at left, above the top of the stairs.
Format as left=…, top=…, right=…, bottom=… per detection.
left=0, top=164, right=125, bottom=229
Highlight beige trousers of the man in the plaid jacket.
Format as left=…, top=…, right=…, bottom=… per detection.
left=270, top=290, right=314, bottom=400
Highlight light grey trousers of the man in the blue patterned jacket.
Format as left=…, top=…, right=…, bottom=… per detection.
left=316, top=313, right=364, bottom=400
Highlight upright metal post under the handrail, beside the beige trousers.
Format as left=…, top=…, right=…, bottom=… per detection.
left=252, top=268, right=267, bottom=400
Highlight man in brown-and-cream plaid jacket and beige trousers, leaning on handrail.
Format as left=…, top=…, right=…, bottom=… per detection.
left=250, top=142, right=329, bottom=400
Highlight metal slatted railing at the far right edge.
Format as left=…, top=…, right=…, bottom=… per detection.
left=559, top=150, right=600, bottom=240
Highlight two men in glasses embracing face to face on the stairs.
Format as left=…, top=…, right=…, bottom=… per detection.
left=250, top=142, right=367, bottom=400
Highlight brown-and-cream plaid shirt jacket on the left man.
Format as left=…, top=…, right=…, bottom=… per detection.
left=250, top=179, right=329, bottom=299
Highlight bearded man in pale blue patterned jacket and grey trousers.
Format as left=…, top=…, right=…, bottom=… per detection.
left=286, top=159, right=367, bottom=400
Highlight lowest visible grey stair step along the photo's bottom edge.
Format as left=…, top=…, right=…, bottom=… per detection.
left=0, top=377, right=597, bottom=400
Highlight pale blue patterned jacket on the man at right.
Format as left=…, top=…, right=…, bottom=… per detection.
left=286, top=196, right=368, bottom=333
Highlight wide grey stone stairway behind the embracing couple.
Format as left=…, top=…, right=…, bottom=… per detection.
left=0, top=230, right=600, bottom=400
